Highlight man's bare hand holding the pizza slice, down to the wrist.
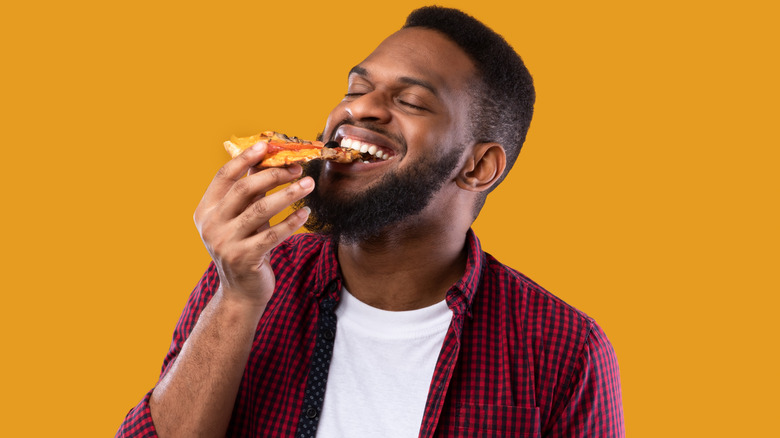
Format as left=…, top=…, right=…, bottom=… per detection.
left=194, top=142, right=314, bottom=307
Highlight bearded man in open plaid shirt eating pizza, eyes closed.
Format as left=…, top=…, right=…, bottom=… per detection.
left=118, top=7, right=623, bottom=437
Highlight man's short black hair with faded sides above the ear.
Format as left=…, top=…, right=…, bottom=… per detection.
left=403, top=6, right=536, bottom=198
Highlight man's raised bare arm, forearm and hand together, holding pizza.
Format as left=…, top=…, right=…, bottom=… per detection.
left=139, top=142, right=314, bottom=438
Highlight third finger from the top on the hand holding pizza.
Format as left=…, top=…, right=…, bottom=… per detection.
left=232, top=177, right=314, bottom=237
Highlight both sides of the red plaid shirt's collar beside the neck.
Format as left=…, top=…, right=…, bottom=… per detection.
left=311, top=229, right=486, bottom=316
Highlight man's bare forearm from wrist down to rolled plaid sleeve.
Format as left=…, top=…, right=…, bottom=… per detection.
left=150, top=289, right=264, bottom=438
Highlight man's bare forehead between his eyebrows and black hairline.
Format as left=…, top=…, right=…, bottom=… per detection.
left=360, top=27, right=476, bottom=95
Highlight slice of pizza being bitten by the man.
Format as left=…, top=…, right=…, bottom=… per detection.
left=224, top=131, right=363, bottom=167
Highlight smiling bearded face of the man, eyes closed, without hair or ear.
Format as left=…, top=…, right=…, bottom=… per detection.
left=305, top=28, right=475, bottom=240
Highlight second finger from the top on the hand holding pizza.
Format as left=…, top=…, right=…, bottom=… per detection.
left=219, top=166, right=303, bottom=221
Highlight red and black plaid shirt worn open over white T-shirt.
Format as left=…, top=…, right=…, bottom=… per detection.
left=117, top=231, right=624, bottom=437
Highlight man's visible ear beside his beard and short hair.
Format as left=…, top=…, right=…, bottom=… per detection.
left=456, top=143, right=506, bottom=192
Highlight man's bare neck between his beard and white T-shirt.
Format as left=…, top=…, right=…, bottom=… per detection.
left=338, top=222, right=468, bottom=311
